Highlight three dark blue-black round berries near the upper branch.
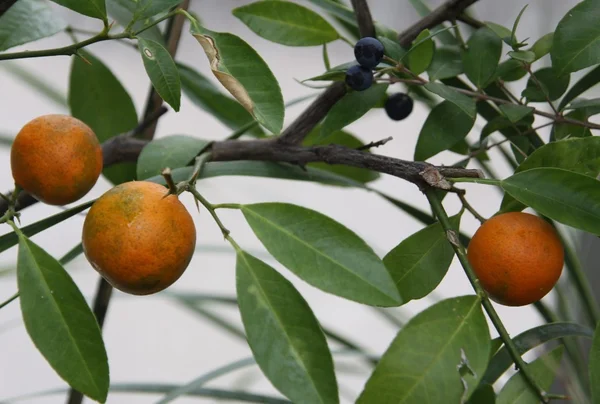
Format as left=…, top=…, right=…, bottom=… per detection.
left=346, top=37, right=413, bottom=121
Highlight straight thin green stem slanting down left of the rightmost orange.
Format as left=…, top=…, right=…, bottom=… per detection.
left=425, top=188, right=548, bottom=403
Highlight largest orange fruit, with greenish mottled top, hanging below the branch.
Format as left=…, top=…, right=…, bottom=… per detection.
left=83, top=181, right=196, bottom=295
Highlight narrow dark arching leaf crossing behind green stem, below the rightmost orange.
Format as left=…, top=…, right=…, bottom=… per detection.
left=482, top=323, right=593, bottom=384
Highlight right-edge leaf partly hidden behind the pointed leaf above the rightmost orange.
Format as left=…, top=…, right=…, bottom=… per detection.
left=500, top=137, right=600, bottom=212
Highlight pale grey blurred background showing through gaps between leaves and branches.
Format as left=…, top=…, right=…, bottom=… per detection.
left=0, top=0, right=597, bottom=404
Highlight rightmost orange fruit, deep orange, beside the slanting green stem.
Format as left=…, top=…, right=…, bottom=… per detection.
left=467, top=212, right=564, bottom=306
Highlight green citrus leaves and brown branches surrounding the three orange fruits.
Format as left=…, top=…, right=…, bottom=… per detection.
left=0, top=0, right=600, bottom=404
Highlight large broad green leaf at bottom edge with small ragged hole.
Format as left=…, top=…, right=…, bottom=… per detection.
left=357, top=296, right=490, bottom=404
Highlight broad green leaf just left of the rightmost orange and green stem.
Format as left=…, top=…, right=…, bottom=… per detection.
left=383, top=216, right=460, bottom=302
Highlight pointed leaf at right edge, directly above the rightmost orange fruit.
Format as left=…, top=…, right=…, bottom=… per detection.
left=502, top=168, right=600, bottom=235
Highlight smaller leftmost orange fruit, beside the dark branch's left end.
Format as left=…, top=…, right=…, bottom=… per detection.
left=10, top=115, right=102, bottom=205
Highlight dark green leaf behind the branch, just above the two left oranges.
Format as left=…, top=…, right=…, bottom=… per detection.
left=69, top=50, right=138, bottom=184
